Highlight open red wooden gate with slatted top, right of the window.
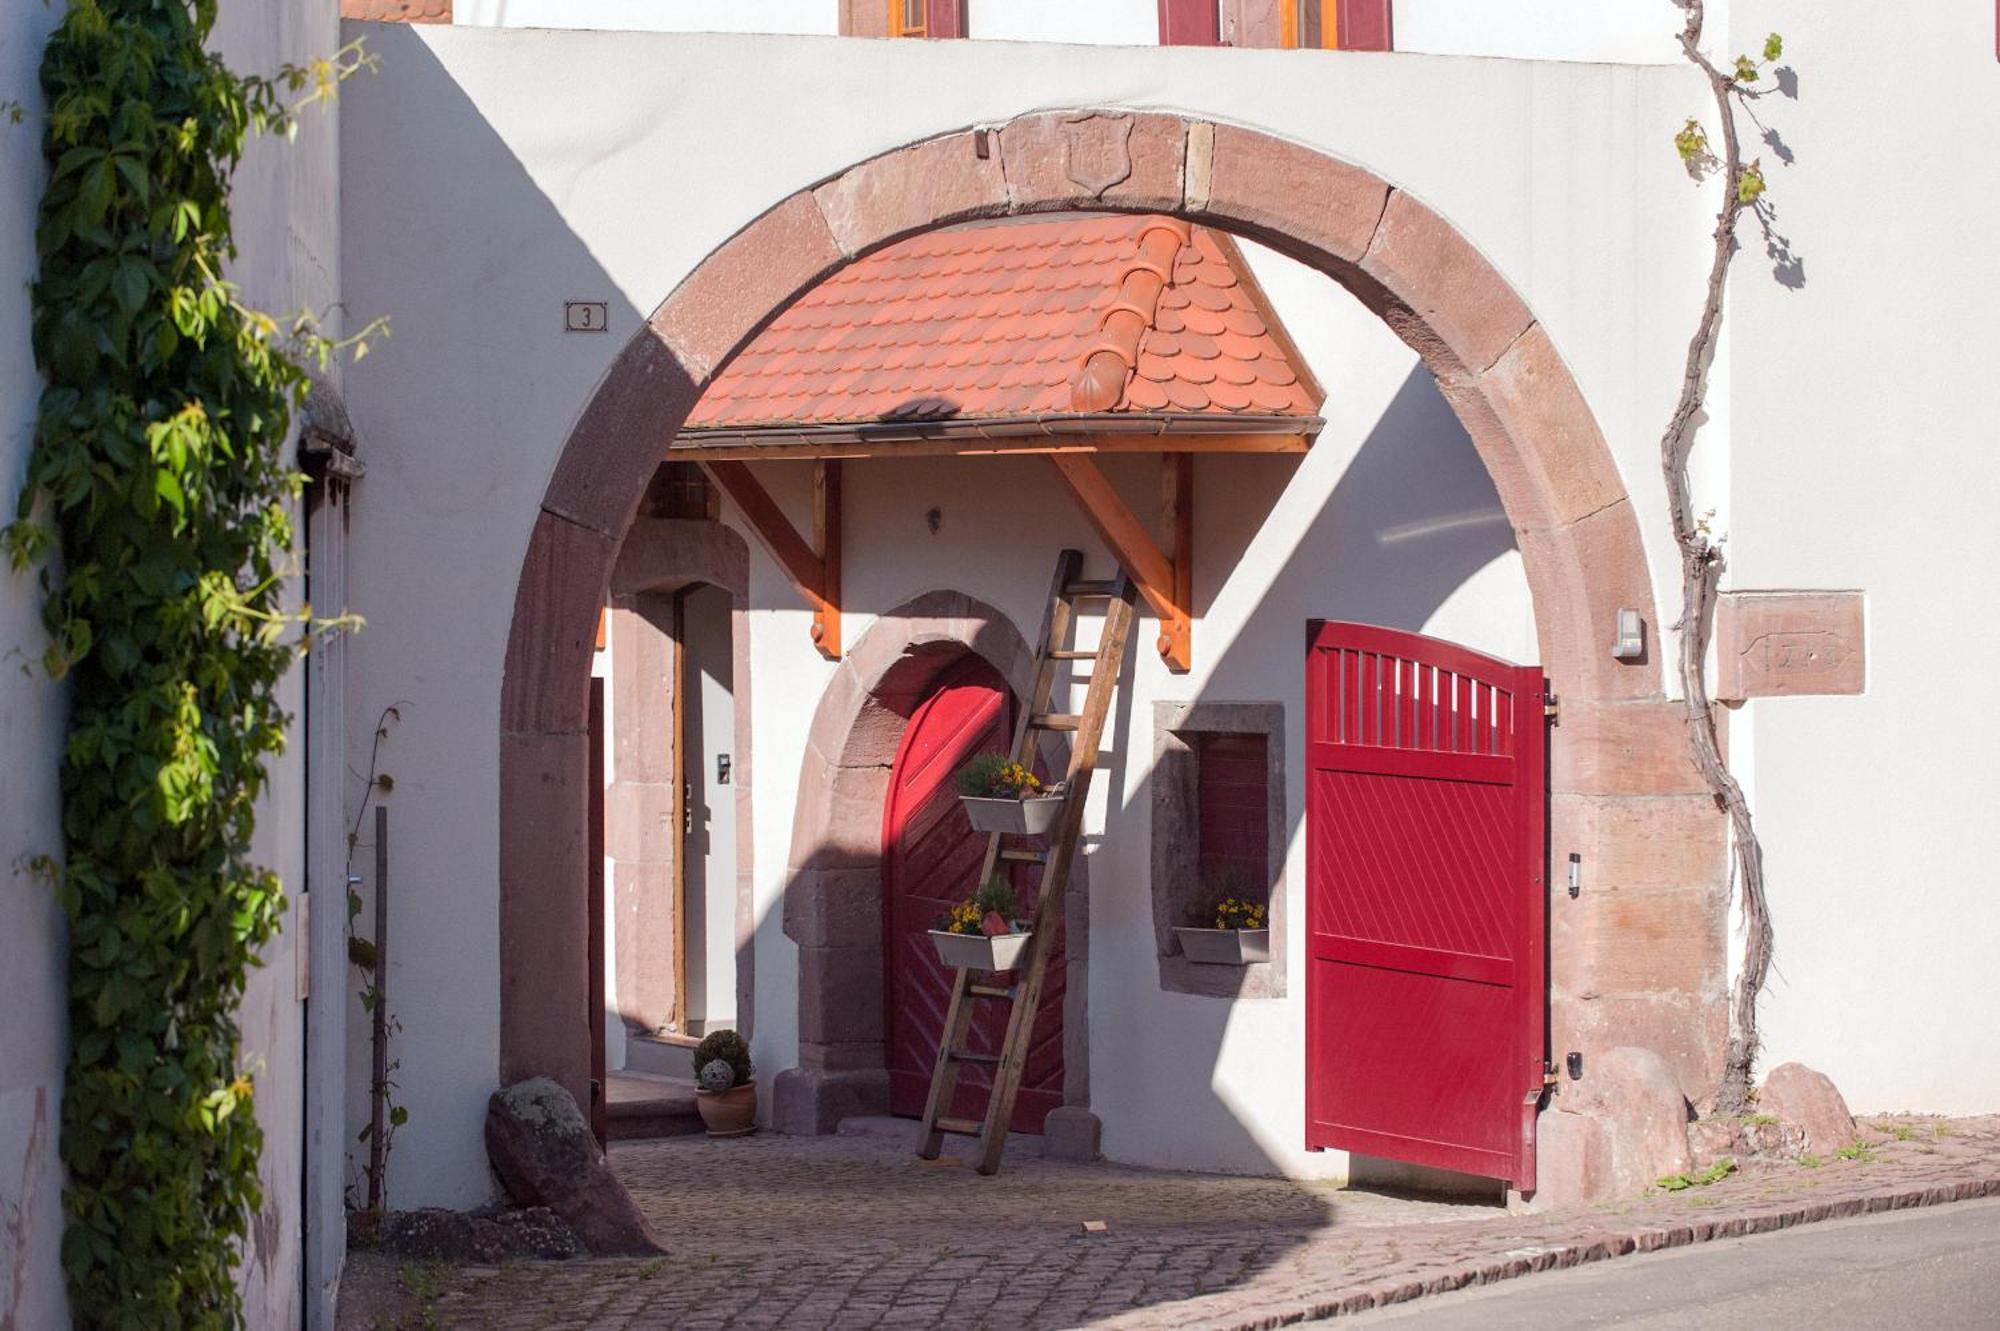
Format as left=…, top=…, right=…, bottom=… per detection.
left=1306, top=622, right=1548, bottom=1191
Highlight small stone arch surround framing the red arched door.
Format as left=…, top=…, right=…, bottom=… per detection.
left=774, top=592, right=1096, bottom=1153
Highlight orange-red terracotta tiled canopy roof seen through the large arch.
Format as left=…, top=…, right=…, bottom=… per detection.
left=686, top=216, right=1324, bottom=429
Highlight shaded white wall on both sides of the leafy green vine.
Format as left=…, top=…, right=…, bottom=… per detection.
left=0, top=0, right=338, bottom=1329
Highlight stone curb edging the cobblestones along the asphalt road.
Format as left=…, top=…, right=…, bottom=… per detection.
left=1160, top=1175, right=2000, bottom=1331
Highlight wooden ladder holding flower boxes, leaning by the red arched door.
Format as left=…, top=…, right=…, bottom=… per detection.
left=918, top=550, right=1134, bottom=1173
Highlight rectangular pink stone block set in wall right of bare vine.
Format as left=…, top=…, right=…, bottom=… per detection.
left=1716, top=592, right=1868, bottom=701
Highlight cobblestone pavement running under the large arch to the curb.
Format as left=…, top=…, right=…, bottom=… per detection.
left=340, top=1115, right=2000, bottom=1331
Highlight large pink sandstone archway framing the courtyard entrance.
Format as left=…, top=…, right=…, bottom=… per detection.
left=500, top=110, right=1728, bottom=1183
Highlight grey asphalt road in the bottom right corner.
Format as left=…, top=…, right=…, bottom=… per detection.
left=1356, top=1201, right=2000, bottom=1331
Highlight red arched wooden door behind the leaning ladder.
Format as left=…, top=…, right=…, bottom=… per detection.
left=882, top=656, right=1064, bottom=1133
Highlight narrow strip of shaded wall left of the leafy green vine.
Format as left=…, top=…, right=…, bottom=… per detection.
left=0, top=4, right=68, bottom=1327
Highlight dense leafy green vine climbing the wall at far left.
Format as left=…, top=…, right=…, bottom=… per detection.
left=0, top=0, right=368, bottom=1327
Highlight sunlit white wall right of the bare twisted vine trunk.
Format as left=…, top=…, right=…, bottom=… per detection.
left=1730, top=0, right=2000, bottom=1111
